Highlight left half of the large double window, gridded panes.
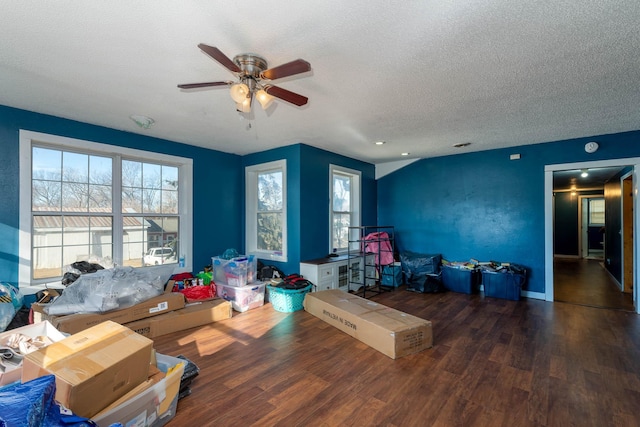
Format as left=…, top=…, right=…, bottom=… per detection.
left=31, top=146, right=113, bottom=280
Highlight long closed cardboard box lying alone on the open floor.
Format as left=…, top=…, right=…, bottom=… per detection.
left=304, top=289, right=433, bottom=359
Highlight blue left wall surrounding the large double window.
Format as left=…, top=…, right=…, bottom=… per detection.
left=0, top=106, right=244, bottom=282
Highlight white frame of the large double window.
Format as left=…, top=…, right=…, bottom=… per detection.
left=18, top=129, right=193, bottom=290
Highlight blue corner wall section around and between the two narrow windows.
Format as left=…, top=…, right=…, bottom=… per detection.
left=242, top=144, right=376, bottom=274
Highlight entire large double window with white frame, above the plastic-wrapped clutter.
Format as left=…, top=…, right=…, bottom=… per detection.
left=19, top=131, right=192, bottom=285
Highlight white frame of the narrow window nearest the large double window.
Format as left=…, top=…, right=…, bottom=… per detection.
left=245, top=159, right=288, bottom=262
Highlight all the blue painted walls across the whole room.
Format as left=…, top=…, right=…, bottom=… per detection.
left=0, top=106, right=640, bottom=298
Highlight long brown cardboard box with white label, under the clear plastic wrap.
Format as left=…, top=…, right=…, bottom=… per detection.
left=31, top=290, right=185, bottom=334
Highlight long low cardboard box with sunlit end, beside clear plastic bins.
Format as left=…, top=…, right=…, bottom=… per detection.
left=125, top=299, right=232, bottom=338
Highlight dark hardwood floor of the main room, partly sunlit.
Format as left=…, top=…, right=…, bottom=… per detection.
left=155, top=288, right=640, bottom=427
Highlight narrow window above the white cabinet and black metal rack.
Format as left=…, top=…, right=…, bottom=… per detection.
left=329, top=165, right=360, bottom=253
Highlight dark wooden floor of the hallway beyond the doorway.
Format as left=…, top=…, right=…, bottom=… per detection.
left=553, top=258, right=635, bottom=311
